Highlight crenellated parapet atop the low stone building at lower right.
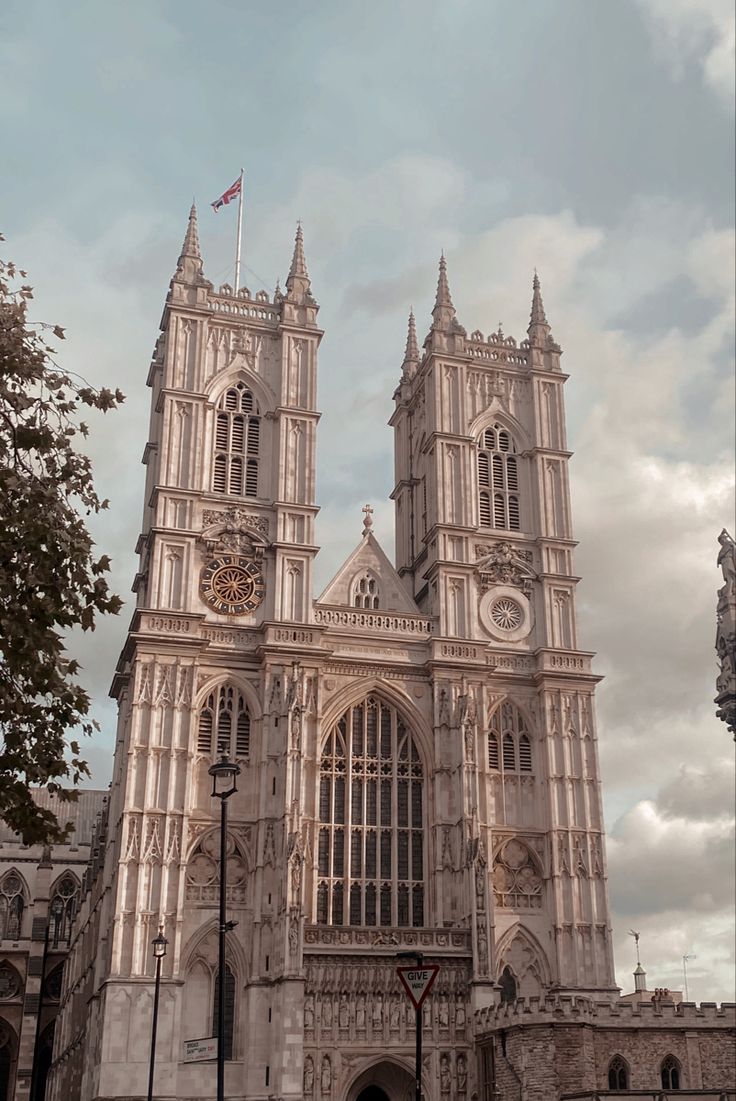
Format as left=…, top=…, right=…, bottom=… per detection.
left=474, top=994, right=736, bottom=1037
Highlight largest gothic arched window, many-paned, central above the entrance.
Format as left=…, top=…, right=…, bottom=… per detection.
left=316, top=696, right=424, bottom=926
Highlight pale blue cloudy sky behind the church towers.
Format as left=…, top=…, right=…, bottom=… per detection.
left=0, top=0, right=734, bottom=1000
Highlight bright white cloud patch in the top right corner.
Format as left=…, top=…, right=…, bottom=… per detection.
left=638, top=0, right=736, bottom=108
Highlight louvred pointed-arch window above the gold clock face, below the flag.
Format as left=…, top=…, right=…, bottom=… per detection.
left=213, top=382, right=261, bottom=497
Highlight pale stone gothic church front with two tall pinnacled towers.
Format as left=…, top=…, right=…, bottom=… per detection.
left=51, top=208, right=615, bottom=1101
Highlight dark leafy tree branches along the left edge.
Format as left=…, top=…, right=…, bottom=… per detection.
left=0, top=236, right=123, bottom=843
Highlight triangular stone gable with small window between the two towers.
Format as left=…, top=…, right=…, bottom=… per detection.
left=317, top=532, right=422, bottom=615
